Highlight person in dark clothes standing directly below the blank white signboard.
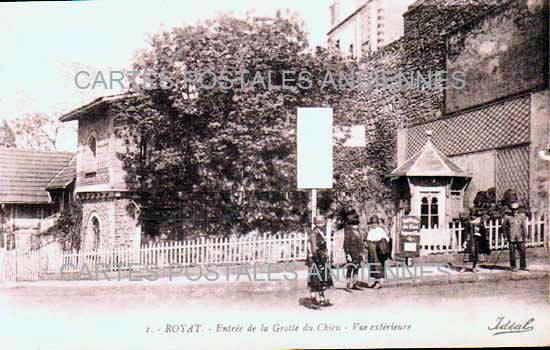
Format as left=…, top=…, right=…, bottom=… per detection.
left=306, top=216, right=334, bottom=306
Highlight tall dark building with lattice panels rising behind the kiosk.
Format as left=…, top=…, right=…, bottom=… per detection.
left=397, top=0, right=550, bottom=210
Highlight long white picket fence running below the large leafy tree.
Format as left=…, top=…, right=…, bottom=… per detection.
left=5, top=233, right=307, bottom=274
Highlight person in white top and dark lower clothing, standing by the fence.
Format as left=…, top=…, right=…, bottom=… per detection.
left=367, top=215, right=390, bottom=289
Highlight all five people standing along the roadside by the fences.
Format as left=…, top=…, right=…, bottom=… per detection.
left=306, top=203, right=527, bottom=306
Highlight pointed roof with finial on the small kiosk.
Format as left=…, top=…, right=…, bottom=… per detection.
left=389, top=134, right=472, bottom=178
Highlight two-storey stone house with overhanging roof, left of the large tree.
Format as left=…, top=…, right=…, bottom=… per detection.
left=60, top=95, right=141, bottom=250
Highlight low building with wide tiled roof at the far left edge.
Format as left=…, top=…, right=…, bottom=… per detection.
left=0, top=147, right=74, bottom=248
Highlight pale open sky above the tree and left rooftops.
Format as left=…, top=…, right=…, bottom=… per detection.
left=0, top=0, right=329, bottom=151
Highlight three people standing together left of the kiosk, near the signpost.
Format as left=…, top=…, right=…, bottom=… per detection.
left=306, top=210, right=391, bottom=306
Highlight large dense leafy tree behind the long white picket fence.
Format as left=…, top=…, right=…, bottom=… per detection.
left=116, top=15, right=398, bottom=233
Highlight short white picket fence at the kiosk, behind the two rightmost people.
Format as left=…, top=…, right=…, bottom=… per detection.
left=420, top=214, right=548, bottom=255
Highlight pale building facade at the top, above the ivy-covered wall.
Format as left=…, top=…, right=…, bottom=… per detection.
left=327, top=0, right=413, bottom=57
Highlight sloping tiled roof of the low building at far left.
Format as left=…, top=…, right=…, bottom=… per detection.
left=0, top=148, right=74, bottom=203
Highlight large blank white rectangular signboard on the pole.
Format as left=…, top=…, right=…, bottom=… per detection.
left=296, top=108, right=332, bottom=189
